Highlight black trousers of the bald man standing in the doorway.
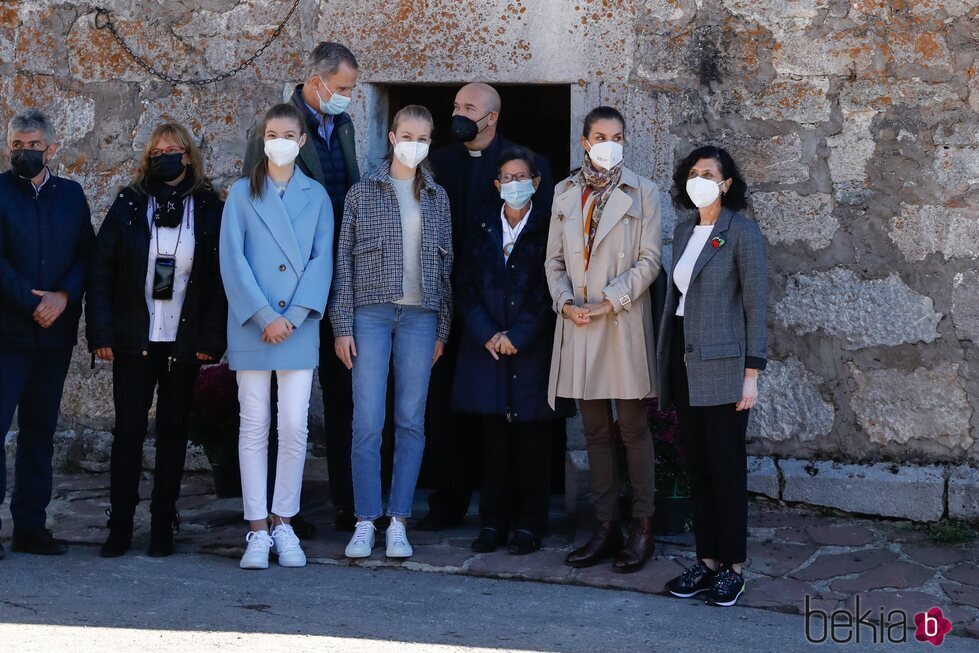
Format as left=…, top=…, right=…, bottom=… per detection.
left=425, top=322, right=482, bottom=521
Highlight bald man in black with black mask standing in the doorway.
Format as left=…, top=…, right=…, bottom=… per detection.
left=418, top=84, right=554, bottom=530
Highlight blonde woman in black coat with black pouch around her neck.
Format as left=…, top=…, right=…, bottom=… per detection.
left=85, top=122, right=228, bottom=558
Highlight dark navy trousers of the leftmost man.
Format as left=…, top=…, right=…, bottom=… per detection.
left=0, top=347, right=72, bottom=532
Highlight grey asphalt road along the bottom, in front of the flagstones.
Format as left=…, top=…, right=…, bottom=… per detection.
left=0, top=547, right=974, bottom=653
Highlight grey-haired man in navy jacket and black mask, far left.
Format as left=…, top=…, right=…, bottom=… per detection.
left=0, top=110, right=95, bottom=557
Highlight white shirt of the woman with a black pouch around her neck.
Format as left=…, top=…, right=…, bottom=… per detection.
left=144, top=197, right=194, bottom=342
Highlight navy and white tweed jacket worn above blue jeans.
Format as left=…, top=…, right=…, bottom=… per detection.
left=329, top=162, right=452, bottom=342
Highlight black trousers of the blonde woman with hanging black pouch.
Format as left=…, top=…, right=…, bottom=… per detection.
left=109, top=343, right=200, bottom=519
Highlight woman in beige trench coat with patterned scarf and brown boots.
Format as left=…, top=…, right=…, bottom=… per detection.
left=545, top=107, right=663, bottom=572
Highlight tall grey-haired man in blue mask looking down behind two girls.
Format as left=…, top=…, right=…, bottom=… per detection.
left=245, top=42, right=360, bottom=537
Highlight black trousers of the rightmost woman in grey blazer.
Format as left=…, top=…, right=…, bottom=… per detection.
left=670, top=318, right=748, bottom=564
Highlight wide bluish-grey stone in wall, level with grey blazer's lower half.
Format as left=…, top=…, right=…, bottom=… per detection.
left=775, top=267, right=942, bottom=350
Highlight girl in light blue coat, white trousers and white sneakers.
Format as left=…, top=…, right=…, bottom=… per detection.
left=220, top=104, right=333, bottom=569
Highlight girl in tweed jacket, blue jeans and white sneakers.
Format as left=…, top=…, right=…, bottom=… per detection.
left=329, top=105, right=452, bottom=558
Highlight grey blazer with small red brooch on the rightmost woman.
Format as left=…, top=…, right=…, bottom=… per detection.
left=656, top=209, right=768, bottom=406
